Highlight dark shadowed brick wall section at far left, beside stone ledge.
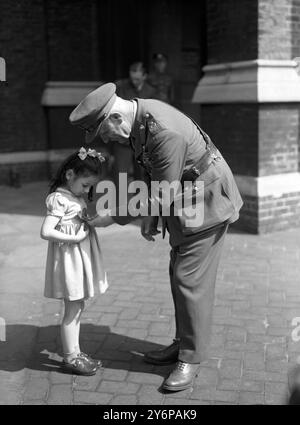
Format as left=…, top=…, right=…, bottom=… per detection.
left=0, top=0, right=47, bottom=152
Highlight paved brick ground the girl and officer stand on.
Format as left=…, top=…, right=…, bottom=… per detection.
left=0, top=182, right=300, bottom=405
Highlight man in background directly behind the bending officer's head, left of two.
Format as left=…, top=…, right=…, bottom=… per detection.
left=112, top=62, right=157, bottom=184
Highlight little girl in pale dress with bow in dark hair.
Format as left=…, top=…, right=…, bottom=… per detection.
left=41, top=148, right=108, bottom=375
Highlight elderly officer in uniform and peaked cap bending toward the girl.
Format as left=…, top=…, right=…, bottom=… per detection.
left=70, top=83, right=242, bottom=391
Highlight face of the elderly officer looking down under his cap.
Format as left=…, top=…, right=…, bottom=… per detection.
left=99, top=113, right=131, bottom=145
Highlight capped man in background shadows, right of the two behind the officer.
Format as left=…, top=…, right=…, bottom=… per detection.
left=148, top=53, right=174, bottom=104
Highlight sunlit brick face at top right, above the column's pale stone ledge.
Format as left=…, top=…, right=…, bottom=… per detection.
left=258, top=0, right=293, bottom=59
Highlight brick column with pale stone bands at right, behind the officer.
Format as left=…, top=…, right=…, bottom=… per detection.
left=193, top=0, right=300, bottom=233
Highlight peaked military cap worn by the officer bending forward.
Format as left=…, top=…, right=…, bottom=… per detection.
left=69, top=83, right=117, bottom=143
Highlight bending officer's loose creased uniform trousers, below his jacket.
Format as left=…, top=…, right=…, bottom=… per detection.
left=169, top=224, right=228, bottom=363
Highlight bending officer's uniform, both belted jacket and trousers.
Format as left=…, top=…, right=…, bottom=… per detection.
left=114, top=99, right=243, bottom=363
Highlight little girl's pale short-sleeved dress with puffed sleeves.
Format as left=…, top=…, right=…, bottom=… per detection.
left=44, top=188, right=108, bottom=301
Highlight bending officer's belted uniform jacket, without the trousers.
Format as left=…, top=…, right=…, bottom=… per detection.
left=114, top=99, right=243, bottom=246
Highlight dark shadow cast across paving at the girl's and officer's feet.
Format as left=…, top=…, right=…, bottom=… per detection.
left=0, top=323, right=172, bottom=377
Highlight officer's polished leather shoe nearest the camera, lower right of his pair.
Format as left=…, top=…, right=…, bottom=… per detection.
left=162, top=360, right=200, bottom=391
